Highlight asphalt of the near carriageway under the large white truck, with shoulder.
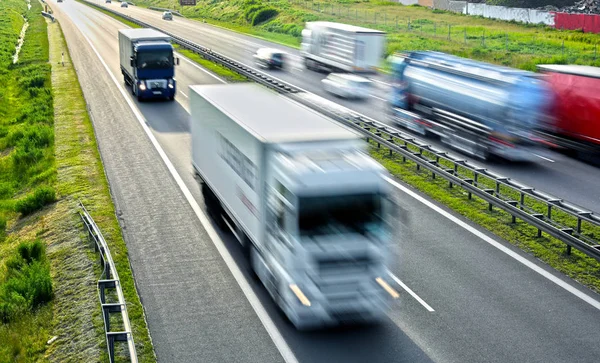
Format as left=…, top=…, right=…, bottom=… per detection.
left=50, top=0, right=600, bottom=362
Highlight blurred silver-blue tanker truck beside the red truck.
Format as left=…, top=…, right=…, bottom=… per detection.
left=389, top=52, right=551, bottom=161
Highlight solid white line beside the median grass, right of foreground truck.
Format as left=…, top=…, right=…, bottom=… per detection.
left=385, top=177, right=600, bottom=310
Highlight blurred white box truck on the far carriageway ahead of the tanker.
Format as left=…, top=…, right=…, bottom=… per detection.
left=301, top=21, right=386, bottom=73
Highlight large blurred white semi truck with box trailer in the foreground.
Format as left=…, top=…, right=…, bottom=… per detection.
left=190, top=84, right=398, bottom=329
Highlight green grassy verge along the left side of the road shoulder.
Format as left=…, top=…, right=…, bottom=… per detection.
left=0, top=0, right=156, bottom=362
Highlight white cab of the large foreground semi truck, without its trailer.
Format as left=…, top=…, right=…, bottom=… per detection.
left=251, top=145, right=395, bottom=329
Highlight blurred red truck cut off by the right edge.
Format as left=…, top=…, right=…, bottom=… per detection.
left=538, top=65, right=600, bottom=154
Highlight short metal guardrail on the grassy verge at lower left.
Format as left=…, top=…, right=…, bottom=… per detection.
left=79, top=202, right=138, bottom=363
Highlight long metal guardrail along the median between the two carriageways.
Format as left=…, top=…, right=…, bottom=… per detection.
left=84, top=0, right=600, bottom=261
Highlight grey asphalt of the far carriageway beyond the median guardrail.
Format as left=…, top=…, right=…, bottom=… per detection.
left=88, top=0, right=600, bottom=212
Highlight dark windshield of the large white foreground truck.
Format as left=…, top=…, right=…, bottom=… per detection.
left=298, top=194, right=382, bottom=237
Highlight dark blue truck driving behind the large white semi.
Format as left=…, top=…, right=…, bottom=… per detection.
left=119, top=29, right=179, bottom=101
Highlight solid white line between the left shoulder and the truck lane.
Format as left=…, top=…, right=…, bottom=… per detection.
left=81, top=29, right=298, bottom=363
